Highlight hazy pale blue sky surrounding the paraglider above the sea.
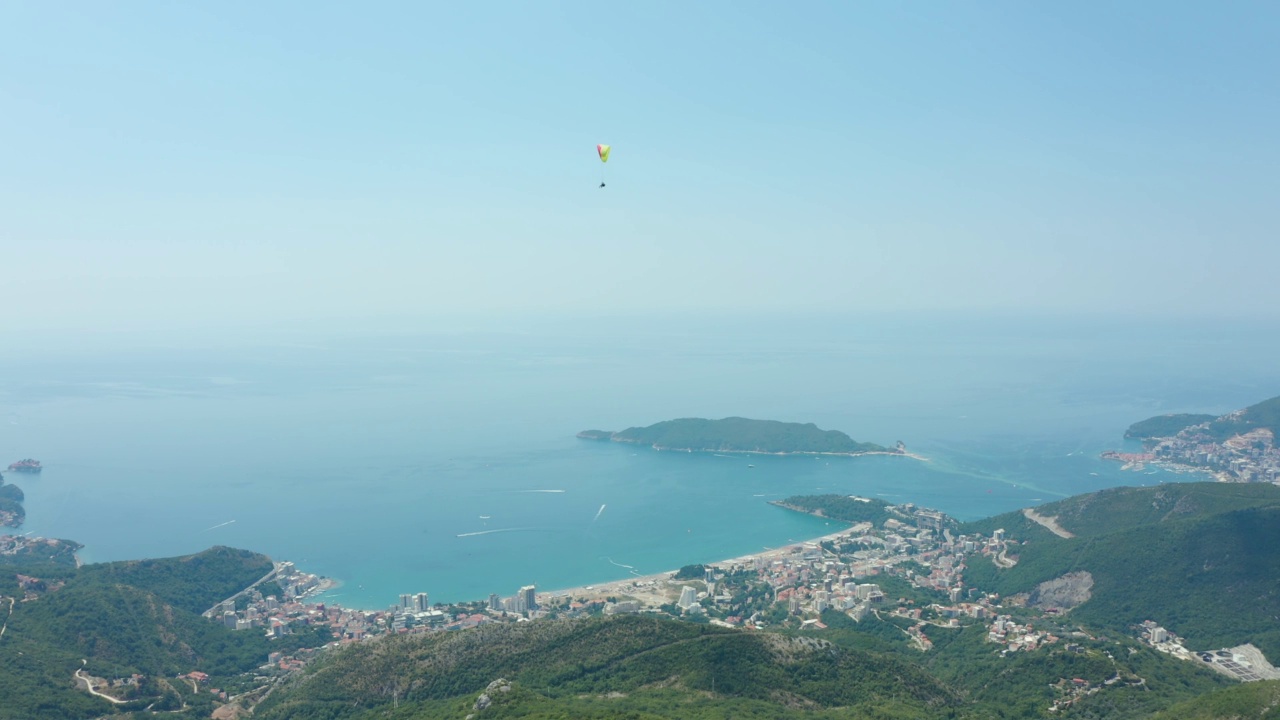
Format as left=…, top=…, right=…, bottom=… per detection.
left=0, top=1, right=1280, bottom=329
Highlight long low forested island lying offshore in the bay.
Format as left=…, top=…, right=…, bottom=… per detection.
left=577, top=418, right=906, bottom=455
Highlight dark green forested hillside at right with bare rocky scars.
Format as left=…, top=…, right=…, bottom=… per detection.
left=960, top=483, right=1280, bottom=657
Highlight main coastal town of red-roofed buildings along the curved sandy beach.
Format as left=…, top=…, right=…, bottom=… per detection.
left=137, top=498, right=1139, bottom=702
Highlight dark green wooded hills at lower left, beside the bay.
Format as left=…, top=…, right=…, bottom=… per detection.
left=0, top=544, right=318, bottom=719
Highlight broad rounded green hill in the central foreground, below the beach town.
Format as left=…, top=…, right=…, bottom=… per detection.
left=256, top=616, right=959, bottom=720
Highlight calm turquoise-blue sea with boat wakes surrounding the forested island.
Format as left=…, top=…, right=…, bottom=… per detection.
left=0, top=314, right=1280, bottom=609
